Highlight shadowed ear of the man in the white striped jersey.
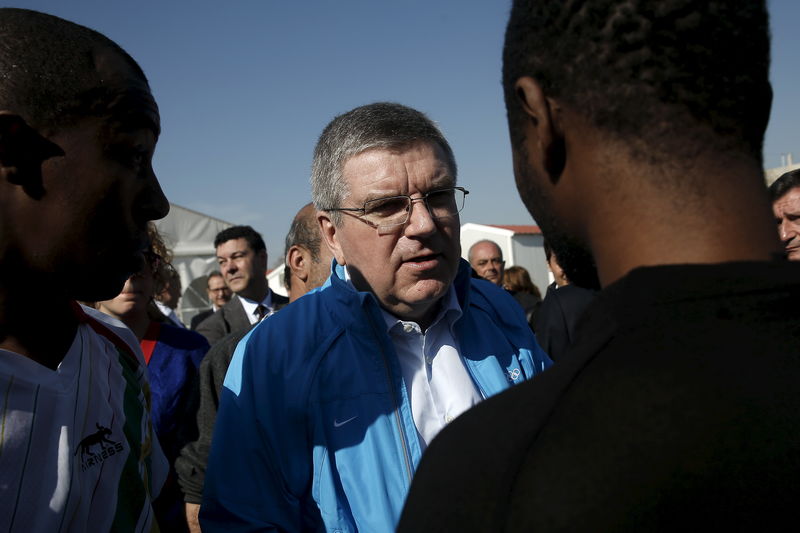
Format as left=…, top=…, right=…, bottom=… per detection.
left=0, top=111, right=64, bottom=199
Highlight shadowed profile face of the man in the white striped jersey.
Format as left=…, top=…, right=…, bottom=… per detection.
left=9, top=47, right=169, bottom=301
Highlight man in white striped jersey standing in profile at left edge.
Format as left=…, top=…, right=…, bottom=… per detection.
left=0, top=9, right=169, bottom=532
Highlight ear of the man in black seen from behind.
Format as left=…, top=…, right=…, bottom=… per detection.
left=514, top=76, right=567, bottom=183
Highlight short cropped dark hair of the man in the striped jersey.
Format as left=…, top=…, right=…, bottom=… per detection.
left=0, top=8, right=147, bottom=131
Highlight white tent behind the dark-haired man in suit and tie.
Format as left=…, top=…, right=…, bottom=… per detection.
left=155, top=204, right=234, bottom=324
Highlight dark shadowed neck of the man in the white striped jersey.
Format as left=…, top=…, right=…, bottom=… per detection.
left=0, top=278, right=78, bottom=370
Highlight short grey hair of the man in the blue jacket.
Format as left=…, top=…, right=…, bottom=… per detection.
left=311, top=102, right=457, bottom=225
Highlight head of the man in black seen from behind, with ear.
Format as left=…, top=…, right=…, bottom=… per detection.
left=503, top=0, right=772, bottom=286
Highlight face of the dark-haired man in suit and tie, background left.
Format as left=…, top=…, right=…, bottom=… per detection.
left=217, top=238, right=267, bottom=300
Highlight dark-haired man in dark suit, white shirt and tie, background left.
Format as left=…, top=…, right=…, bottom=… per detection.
left=197, top=226, right=289, bottom=345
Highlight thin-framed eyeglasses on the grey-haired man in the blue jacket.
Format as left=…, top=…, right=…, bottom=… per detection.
left=323, top=187, right=469, bottom=231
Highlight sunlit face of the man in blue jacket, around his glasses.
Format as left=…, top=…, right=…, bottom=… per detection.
left=321, top=142, right=461, bottom=321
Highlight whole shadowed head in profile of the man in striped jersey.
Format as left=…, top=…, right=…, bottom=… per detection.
left=0, top=8, right=169, bottom=301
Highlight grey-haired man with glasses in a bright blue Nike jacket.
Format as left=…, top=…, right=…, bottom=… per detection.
left=200, top=103, right=550, bottom=532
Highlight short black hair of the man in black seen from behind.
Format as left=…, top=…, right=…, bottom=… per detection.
left=503, top=0, right=772, bottom=163
